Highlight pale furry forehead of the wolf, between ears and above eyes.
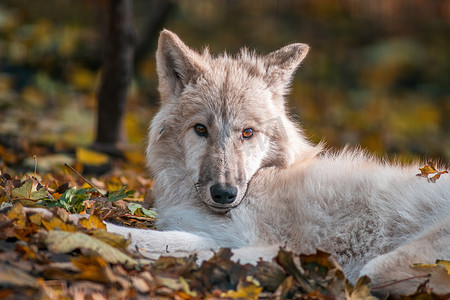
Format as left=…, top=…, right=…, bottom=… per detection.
left=178, top=58, right=273, bottom=126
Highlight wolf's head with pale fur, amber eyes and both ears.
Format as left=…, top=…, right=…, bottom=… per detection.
left=147, top=30, right=318, bottom=213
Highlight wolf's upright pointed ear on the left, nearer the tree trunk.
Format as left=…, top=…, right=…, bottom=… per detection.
left=156, top=29, right=201, bottom=104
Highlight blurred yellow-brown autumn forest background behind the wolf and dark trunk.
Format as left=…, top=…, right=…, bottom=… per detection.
left=0, top=0, right=450, bottom=175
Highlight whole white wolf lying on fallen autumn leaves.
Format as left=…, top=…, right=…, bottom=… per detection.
left=108, top=30, right=450, bottom=293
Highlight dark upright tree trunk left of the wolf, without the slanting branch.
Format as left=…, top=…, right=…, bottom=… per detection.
left=93, top=0, right=136, bottom=154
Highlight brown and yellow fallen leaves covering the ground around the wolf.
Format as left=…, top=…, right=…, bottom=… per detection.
left=0, top=164, right=450, bottom=299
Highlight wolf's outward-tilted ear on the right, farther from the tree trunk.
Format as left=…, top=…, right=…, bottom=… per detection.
left=265, top=43, right=309, bottom=90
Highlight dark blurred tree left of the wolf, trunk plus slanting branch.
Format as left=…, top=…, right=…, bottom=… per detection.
left=93, top=0, right=174, bottom=155
